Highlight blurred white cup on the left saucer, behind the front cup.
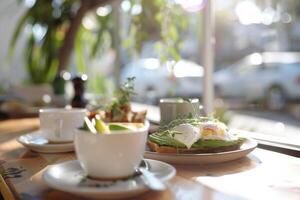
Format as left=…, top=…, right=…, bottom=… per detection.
left=39, top=108, right=86, bottom=142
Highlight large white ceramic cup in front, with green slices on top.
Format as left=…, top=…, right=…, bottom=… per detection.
left=74, top=123, right=149, bottom=179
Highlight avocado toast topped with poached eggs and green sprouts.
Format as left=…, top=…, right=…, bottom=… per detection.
left=147, top=118, right=245, bottom=153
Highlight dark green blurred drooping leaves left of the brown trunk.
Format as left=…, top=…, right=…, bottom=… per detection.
left=9, top=0, right=78, bottom=84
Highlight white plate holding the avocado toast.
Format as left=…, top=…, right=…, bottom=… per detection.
left=144, top=138, right=257, bottom=164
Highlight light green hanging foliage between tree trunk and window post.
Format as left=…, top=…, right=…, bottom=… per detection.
left=123, top=0, right=188, bottom=62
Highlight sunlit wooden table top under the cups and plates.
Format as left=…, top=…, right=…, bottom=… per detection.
left=0, top=119, right=300, bottom=200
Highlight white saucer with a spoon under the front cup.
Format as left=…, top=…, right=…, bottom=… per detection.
left=43, top=159, right=176, bottom=199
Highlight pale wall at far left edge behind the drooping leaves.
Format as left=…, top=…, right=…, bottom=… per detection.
left=0, top=0, right=26, bottom=87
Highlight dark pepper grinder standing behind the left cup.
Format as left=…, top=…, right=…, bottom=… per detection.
left=71, top=74, right=87, bottom=108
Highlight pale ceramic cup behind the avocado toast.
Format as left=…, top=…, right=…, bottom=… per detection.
left=159, top=98, right=203, bottom=123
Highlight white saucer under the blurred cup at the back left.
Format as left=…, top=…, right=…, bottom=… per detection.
left=17, top=131, right=74, bottom=153
